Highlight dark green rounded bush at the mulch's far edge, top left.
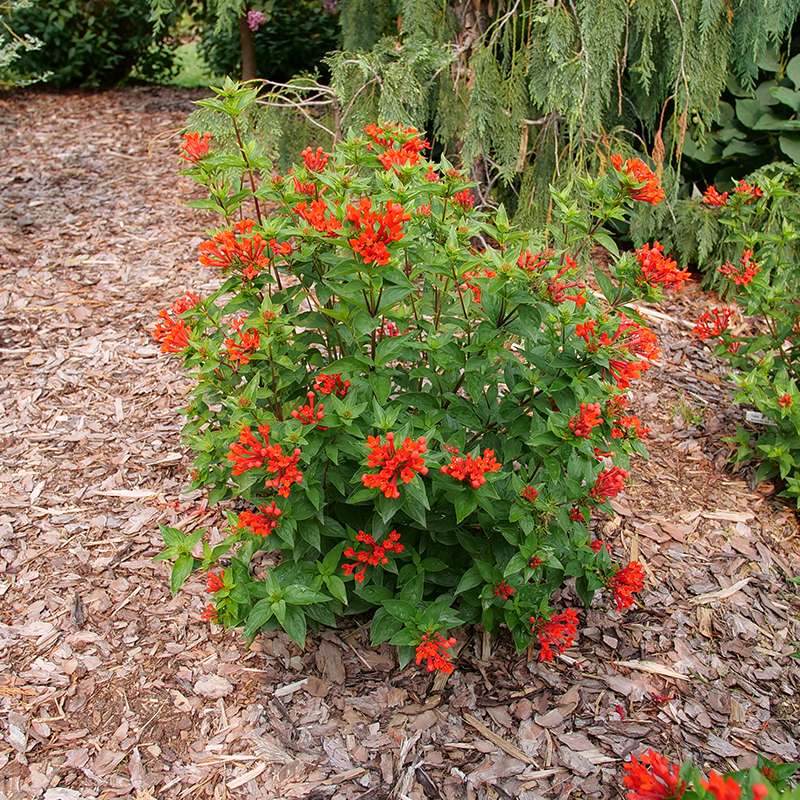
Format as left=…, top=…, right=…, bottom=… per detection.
left=9, top=0, right=172, bottom=87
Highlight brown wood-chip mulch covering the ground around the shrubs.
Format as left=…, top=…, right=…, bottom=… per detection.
left=0, top=89, right=800, bottom=800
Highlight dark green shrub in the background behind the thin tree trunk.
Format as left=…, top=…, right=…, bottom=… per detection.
left=201, top=0, right=339, bottom=82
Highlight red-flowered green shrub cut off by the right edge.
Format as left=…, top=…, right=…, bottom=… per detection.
left=694, top=172, right=800, bottom=504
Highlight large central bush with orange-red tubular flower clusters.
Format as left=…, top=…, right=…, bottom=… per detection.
left=154, top=79, right=684, bottom=672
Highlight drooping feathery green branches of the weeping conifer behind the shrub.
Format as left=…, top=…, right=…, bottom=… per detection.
left=322, top=0, right=800, bottom=218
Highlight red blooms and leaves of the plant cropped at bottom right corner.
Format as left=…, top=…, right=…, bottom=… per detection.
left=622, top=750, right=800, bottom=800
